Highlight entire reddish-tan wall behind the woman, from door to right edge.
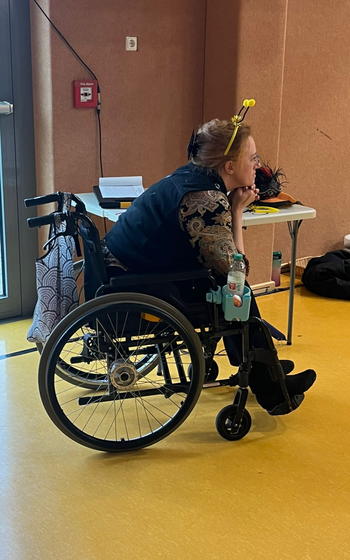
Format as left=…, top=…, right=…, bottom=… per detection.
left=31, top=0, right=350, bottom=283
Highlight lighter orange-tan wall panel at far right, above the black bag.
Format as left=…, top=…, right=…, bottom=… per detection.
left=275, top=0, right=350, bottom=262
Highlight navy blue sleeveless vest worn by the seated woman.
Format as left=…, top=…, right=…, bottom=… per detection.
left=105, top=164, right=227, bottom=272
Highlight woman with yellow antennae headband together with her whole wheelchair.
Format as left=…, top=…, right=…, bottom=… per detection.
left=26, top=100, right=316, bottom=453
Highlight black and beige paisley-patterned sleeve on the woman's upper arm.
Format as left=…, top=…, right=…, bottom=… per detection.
left=179, top=191, right=237, bottom=275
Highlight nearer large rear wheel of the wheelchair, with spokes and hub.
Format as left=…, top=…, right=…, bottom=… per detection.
left=39, top=293, right=205, bottom=452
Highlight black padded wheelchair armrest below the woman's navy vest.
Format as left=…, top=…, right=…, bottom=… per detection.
left=110, top=268, right=216, bottom=288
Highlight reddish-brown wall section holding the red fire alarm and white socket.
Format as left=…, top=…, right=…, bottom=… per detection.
left=31, top=0, right=206, bottom=193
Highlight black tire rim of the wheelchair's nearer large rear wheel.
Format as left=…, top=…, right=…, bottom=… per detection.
left=39, top=293, right=205, bottom=453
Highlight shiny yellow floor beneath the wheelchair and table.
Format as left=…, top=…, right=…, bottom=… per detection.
left=0, top=288, right=350, bottom=560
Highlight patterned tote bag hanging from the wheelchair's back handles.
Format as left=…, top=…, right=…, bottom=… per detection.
left=27, top=193, right=78, bottom=344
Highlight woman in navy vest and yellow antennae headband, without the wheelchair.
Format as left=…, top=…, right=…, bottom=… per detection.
left=102, top=116, right=316, bottom=415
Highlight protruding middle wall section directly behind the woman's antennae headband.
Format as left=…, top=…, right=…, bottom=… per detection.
left=204, top=0, right=285, bottom=284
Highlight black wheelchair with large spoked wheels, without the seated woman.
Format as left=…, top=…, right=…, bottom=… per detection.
left=25, top=192, right=294, bottom=453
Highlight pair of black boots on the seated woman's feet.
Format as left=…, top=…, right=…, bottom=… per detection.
left=249, top=362, right=316, bottom=416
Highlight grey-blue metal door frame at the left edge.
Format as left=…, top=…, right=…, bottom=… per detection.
left=0, top=0, right=38, bottom=319
